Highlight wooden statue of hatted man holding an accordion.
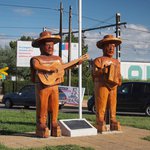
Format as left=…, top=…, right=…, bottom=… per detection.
left=92, top=35, right=122, bottom=132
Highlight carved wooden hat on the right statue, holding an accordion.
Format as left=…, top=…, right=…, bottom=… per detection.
left=96, top=34, right=122, bottom=49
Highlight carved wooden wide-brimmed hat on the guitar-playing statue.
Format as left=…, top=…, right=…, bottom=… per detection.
left=32, top=31, right=60, bottom=47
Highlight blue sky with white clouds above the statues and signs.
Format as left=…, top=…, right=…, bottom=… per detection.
left=0, top=0, right=150, bottom=61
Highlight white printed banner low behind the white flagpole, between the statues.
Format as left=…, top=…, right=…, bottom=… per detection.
left=59, top=86, right=85, bottom=105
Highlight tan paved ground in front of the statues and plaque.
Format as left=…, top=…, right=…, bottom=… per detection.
left=0, top=126, right=150, bottom=150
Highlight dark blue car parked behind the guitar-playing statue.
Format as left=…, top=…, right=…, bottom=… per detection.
left=2, top=85, right=67, bottom=108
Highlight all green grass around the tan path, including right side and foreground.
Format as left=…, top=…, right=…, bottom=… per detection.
left=0, top=109, right=150, bottom=150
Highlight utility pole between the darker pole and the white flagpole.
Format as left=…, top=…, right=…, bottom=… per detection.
left=67, top=6, right=72, bottom=86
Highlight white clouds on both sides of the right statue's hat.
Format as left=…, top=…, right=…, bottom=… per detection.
left=84, top=24, right=150, bottom=61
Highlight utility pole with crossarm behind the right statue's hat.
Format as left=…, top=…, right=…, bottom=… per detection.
left=116, top=13, right=121, bottom=61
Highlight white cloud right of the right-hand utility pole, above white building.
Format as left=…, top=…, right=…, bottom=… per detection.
left=122, top=24, right=150, bottom=61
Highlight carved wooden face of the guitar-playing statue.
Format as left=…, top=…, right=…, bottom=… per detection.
left=40, top=42, right=54, bottom=56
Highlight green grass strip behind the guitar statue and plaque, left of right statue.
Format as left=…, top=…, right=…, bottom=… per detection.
left=0, top=109, right=95, bottom=135
